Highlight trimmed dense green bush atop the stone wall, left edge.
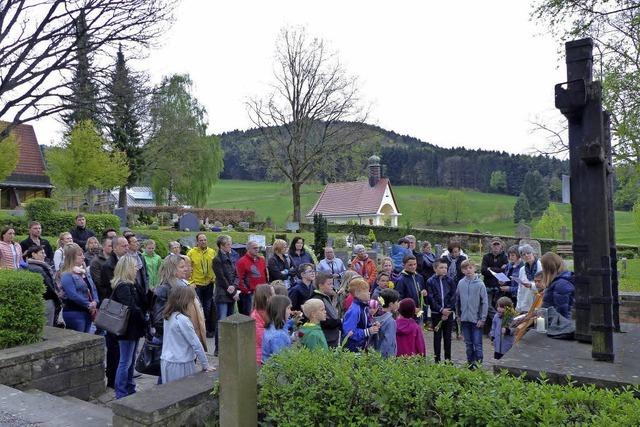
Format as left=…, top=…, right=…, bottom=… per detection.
left=0, top=270, right=44, bottom=348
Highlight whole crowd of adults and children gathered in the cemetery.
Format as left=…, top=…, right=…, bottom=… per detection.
left=0, top=219, right=574, bottom=398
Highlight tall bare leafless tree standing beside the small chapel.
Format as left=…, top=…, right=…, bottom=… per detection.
left=247, top=28, right=366, bottom=221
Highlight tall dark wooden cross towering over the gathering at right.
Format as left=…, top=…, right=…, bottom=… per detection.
left=555, top=39, right=617, bottom=362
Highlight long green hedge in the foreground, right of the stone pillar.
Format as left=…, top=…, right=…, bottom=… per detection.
left=258, top=349, right=640, bottom=426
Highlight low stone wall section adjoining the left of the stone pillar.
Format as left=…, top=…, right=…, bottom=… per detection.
left=111, top=372, right=219, bottom=427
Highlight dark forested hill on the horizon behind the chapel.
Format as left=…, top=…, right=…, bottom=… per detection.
left=221, top=125, right=569, bottom=198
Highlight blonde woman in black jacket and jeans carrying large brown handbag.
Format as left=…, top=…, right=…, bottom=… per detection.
left=111, top=256, right=146, bottom=399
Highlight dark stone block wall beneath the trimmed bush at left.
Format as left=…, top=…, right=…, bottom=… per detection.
left=0, top=327, right=105, bottom=400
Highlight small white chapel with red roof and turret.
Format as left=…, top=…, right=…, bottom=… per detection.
left=306, top=155, right=402, bottom=227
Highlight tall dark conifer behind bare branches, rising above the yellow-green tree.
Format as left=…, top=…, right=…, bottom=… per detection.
left=63, top=11, right=101, bottom=132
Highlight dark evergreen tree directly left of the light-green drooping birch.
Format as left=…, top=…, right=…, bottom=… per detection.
left=106, top=48, right=144, bottom=207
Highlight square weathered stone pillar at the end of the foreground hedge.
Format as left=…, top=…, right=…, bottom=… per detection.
left=218, top=314, right=258, bottom=427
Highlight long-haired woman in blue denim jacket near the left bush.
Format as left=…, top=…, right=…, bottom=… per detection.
left=60, top=243, right=99, bottom=332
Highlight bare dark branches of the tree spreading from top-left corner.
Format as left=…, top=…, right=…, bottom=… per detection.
left=0, top=0, right=175, bottom=137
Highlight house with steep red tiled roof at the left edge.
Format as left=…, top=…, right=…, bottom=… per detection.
left=0, top=124, right=53, bottom=209
